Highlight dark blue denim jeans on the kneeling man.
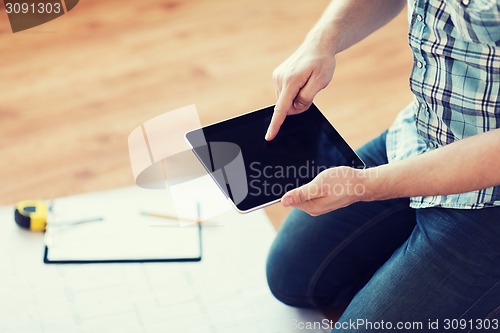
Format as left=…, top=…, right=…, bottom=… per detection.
left=267, top=133, right=500, bottom=332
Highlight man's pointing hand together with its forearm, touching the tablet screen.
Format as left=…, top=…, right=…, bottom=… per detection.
left=266, top=0, right=406, bottom=141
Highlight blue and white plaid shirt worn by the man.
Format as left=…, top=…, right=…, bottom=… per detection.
left=387, top=0, right=500, bottom=209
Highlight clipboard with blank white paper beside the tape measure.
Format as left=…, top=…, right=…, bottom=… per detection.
left=43, top=187, right=202, bottom=264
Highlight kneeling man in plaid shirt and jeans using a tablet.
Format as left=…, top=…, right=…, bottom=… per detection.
left=266, top=0, right=500, bottom=332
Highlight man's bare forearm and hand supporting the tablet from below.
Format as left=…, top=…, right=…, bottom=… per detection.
left=281, top=128, right=500, bottom=216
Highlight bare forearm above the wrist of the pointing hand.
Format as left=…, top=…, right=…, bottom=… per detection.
left=305, top=0, right=406, bottom=55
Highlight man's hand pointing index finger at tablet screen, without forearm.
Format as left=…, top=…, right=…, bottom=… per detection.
left=266, top=43, right=335, bottom=141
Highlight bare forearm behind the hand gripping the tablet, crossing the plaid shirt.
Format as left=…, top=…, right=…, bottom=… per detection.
left=364, top=129, right=500, bottom=201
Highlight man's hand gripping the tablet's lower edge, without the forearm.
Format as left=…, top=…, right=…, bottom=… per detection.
left=281, top=167, right=369, bottom=216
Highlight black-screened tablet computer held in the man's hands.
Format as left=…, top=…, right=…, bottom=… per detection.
left=186, top=104, right=365, bottom=213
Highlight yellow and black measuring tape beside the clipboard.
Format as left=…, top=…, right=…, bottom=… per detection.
left=15, top=200, right=47, bottom=231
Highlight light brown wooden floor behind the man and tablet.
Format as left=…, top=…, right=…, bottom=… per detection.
left=0, top=0, right=411, bottom=227
